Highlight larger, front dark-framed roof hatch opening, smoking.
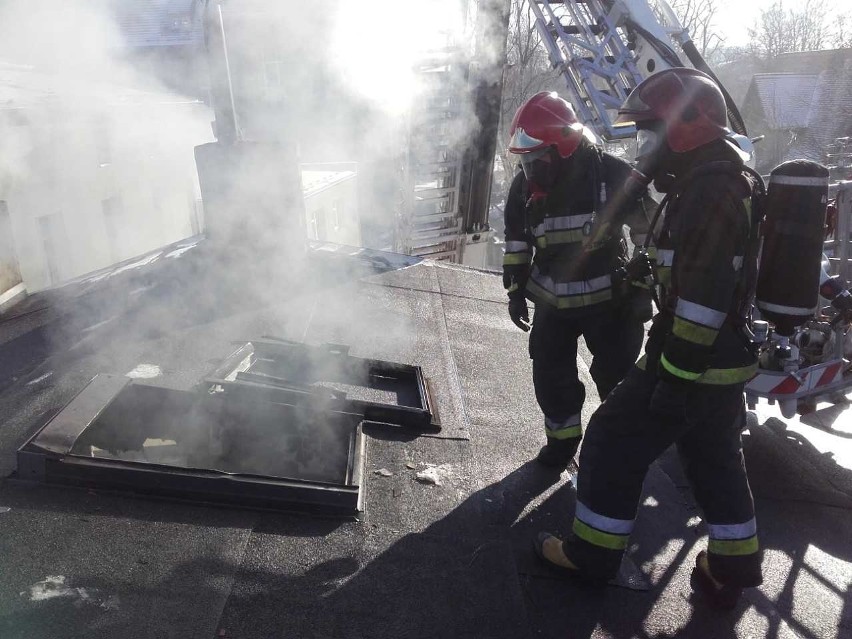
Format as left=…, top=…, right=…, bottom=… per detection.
left=18, top=375, right=365, bottom=516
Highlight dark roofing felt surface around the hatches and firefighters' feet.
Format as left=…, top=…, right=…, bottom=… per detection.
left=0, top=242, right=852, bottom=639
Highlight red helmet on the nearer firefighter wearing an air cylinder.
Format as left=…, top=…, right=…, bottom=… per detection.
left=616, top=67, right=727, bottom=153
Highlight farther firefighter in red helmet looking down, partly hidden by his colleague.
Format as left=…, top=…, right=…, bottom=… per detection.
left=503, top=92, right=655, bottom=469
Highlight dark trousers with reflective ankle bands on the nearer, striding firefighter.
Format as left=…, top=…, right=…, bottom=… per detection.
left=563, top=367, right=762, bottom=587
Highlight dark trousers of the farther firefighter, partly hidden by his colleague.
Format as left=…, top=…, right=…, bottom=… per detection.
left=530, top=305, right=644, bottom=445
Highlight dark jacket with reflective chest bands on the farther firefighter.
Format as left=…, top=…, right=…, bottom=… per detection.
left=503, top=143, right=656, bottom=316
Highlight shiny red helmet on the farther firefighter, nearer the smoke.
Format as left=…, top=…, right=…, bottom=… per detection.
left=509, top=91, right=584, bottom=158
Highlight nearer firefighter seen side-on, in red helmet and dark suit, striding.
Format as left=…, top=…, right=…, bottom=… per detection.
left=535, top=68, right=762, bottom=607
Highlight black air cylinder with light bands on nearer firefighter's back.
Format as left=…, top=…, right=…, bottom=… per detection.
left=755, top=160, right=828, bottom=336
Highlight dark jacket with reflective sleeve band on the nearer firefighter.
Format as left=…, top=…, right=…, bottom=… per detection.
left=638, top=140, right=757, bottom=385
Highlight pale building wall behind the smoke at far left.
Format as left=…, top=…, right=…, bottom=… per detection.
left=0, top=103, right=212, bottom=292
